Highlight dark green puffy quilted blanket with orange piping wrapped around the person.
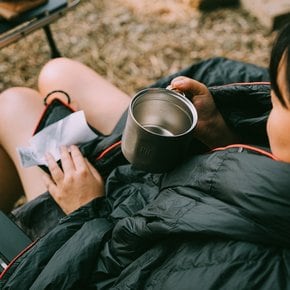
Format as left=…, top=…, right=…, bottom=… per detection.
left=0, top=58, right=290, bottom=290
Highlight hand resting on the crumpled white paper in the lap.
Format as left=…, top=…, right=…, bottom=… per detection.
left=43, top=146, right=104, bottom=214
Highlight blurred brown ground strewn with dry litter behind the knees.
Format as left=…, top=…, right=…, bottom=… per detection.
left=0, top=0, right=274, bottom=95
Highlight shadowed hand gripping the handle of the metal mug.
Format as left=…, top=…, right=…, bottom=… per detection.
left=171, top=76, right=239, bottom=148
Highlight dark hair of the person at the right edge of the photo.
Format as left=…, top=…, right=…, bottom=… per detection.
left=269, top=23, right=290, bottom=107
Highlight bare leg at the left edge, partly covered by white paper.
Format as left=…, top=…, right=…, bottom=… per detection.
left=0, top=88, right=46, bottom=210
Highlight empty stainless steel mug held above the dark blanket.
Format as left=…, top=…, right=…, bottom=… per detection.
left=121, top=88, right=197, bottom=172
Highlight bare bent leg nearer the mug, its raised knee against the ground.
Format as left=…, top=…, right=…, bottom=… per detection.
left=39, top=58, right=130, bottom=134
